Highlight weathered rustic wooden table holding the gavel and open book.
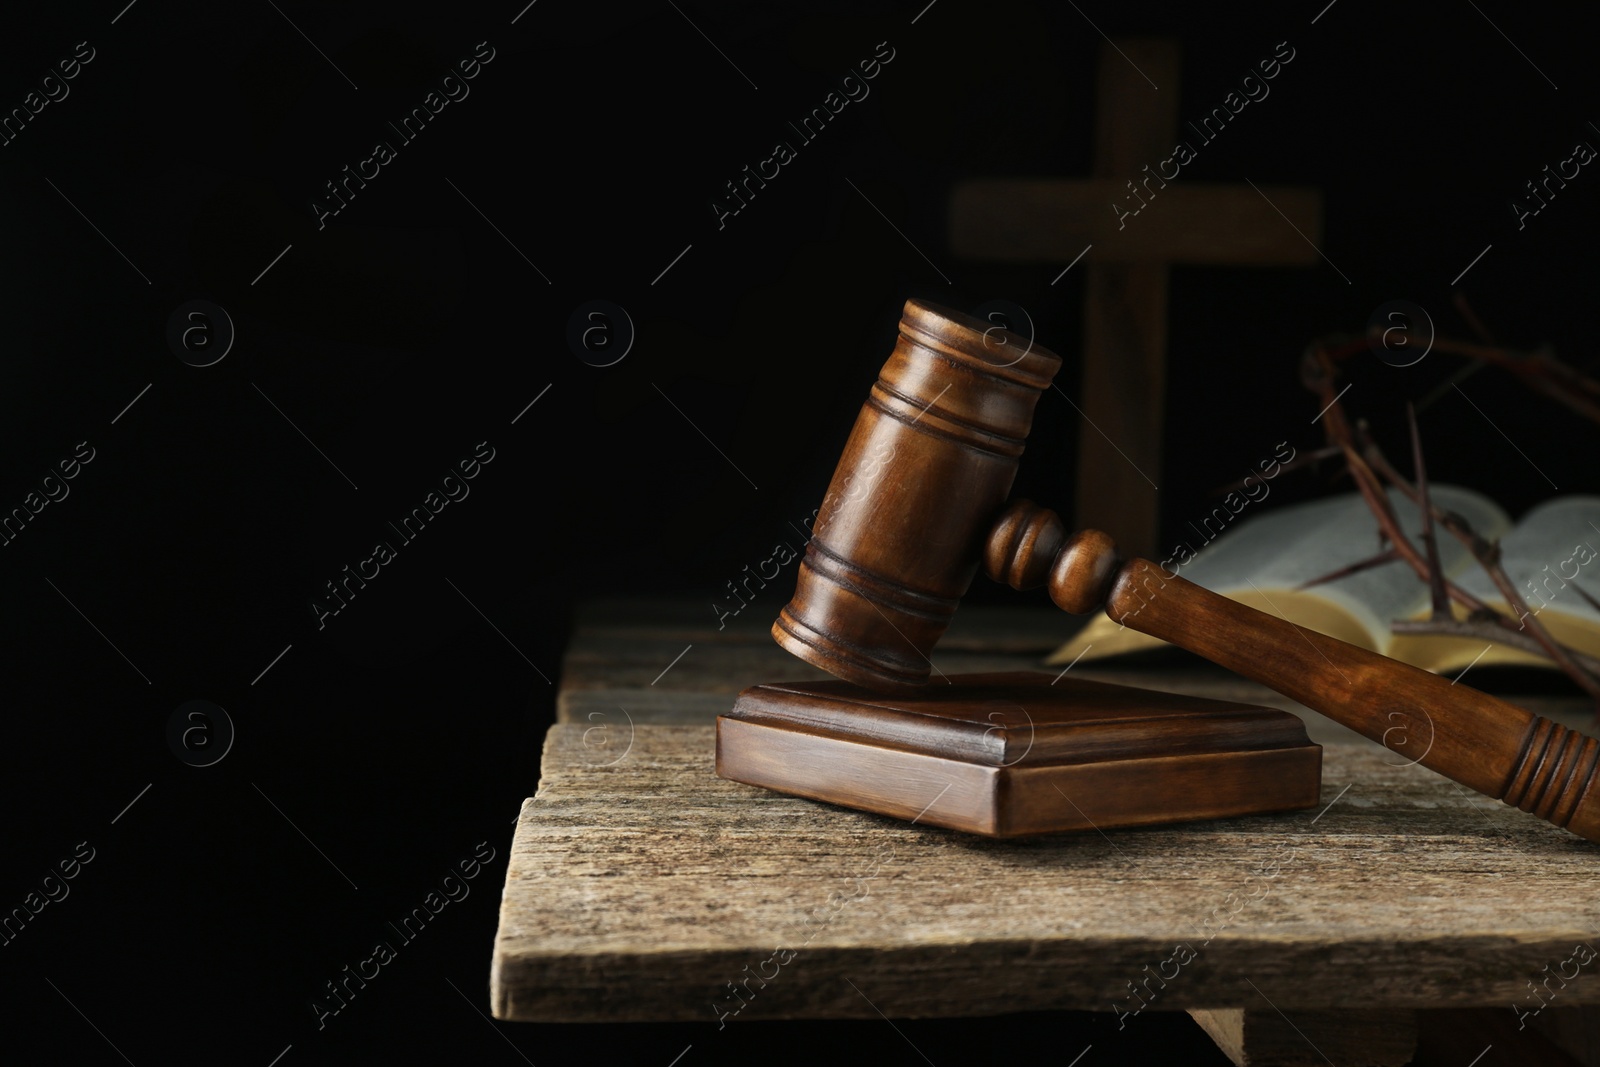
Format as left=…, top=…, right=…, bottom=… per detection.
left=491, top=601, right=1600, bottom=1067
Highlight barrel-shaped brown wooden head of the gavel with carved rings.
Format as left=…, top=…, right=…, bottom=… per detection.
left=773, top=301, right=1061, bottom=689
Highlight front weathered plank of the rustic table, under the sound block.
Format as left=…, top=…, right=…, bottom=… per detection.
left=491, top=725, right=1600, bottom=1022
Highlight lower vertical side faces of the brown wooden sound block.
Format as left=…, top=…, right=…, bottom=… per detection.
left=717, top=715, right=1322, bottom=838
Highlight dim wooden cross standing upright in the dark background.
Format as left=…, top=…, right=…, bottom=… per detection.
left=950, top=40, right=1322, bottom=558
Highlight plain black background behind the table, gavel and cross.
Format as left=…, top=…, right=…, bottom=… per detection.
left=0, top=0, right=1600, bottom=1067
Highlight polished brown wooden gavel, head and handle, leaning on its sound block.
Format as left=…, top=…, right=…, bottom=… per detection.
left=773, top=301, right=1600, bottom=841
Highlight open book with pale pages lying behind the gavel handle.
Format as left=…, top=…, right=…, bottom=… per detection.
left=1048, top=485, right=1600, bottom=673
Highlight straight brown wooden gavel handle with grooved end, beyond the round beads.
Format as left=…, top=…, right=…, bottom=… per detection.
left=1106, top=560, right=1600, bottom=841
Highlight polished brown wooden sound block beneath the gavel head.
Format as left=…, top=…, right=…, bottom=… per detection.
left=717, top=672, right=1322, bottom=837
